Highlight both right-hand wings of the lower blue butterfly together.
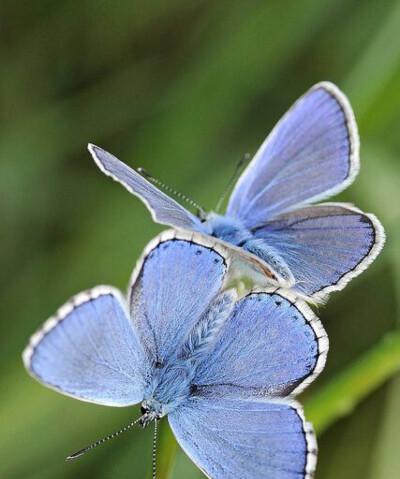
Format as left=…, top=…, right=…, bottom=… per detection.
left=168, top=292, right=322, bottom=479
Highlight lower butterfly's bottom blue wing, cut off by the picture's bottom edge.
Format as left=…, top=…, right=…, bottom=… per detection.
left=168, top=398, right=317, bottom=479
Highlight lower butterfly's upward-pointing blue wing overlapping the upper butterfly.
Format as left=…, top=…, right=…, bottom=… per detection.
left=130, top=232, right=229, bottom=363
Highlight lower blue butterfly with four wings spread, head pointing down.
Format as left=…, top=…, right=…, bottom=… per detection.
left=23, top=230, right=328, bottom=479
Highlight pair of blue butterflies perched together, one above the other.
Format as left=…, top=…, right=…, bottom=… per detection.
left=23, top=83, right=384, bottom=479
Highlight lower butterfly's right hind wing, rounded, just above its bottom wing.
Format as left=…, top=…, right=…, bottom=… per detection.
left=194, top=292, right=328, bottom=399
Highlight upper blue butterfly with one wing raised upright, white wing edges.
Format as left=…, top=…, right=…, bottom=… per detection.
left=89, top=82, right=385, bottom=301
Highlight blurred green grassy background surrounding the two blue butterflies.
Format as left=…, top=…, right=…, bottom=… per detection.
left=0, top=0, right=400, bottom=479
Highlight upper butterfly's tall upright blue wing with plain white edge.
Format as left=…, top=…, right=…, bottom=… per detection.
left=227, top=82, right=359, bottom=228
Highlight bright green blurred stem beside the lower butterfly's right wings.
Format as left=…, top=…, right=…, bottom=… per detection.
left=305, top=330, right=400, bottom=434
